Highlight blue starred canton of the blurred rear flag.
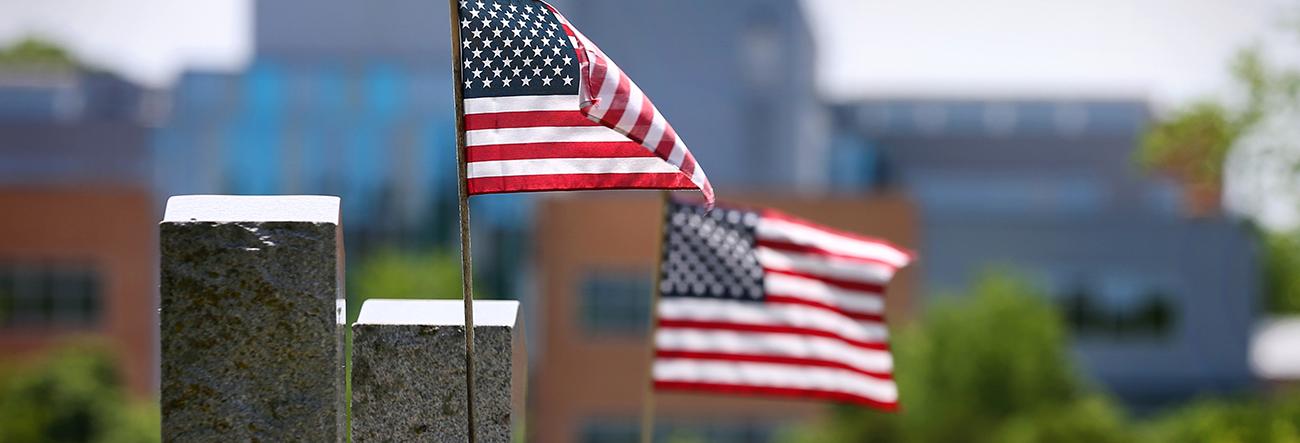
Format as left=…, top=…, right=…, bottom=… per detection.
left=659, top=201, right=763, bottom=301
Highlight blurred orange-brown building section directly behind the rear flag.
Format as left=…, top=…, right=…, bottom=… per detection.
left=528, top=192, right=919, bottom=443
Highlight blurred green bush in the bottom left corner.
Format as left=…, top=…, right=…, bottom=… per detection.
left=0, top=344, right=160, bottom=443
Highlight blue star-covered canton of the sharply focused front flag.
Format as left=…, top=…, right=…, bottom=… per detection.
left=456, top=0, right=580, bottom=98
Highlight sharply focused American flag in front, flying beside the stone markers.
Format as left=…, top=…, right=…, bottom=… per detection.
left=456, top=0, right=712, bottom=201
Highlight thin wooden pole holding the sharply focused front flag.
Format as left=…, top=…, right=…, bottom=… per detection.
left=447, top=0, right=477, bottom=443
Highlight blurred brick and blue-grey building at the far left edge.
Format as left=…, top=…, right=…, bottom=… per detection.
left=0, top=68, right=157, bottom=395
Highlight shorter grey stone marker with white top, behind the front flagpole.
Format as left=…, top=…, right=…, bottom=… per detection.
left=352, top=300, right=528, bottom=443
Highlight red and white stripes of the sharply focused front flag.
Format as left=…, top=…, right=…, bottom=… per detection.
left=464, top=5, right=714, bottom=204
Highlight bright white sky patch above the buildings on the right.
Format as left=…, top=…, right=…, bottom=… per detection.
left=805, top=0, right=1300, bottom=104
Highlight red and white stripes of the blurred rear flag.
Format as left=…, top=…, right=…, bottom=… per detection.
left=654, top=212, right=911, bottom=411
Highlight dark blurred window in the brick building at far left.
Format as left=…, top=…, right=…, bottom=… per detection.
left=0, top=262, right=103, bottom=329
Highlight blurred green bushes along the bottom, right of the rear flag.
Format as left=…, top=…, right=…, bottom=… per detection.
left=783, top=270, right=1300, bottom=443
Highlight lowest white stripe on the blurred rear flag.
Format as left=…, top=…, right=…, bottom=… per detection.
left=654, top=359, right=898, bottom=403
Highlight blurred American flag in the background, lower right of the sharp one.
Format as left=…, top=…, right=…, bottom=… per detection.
left=654, top=201, right=911, bottom=411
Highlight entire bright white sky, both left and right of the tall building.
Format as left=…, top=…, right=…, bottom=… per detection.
left=0, top=0, right=1300, bottom=104
